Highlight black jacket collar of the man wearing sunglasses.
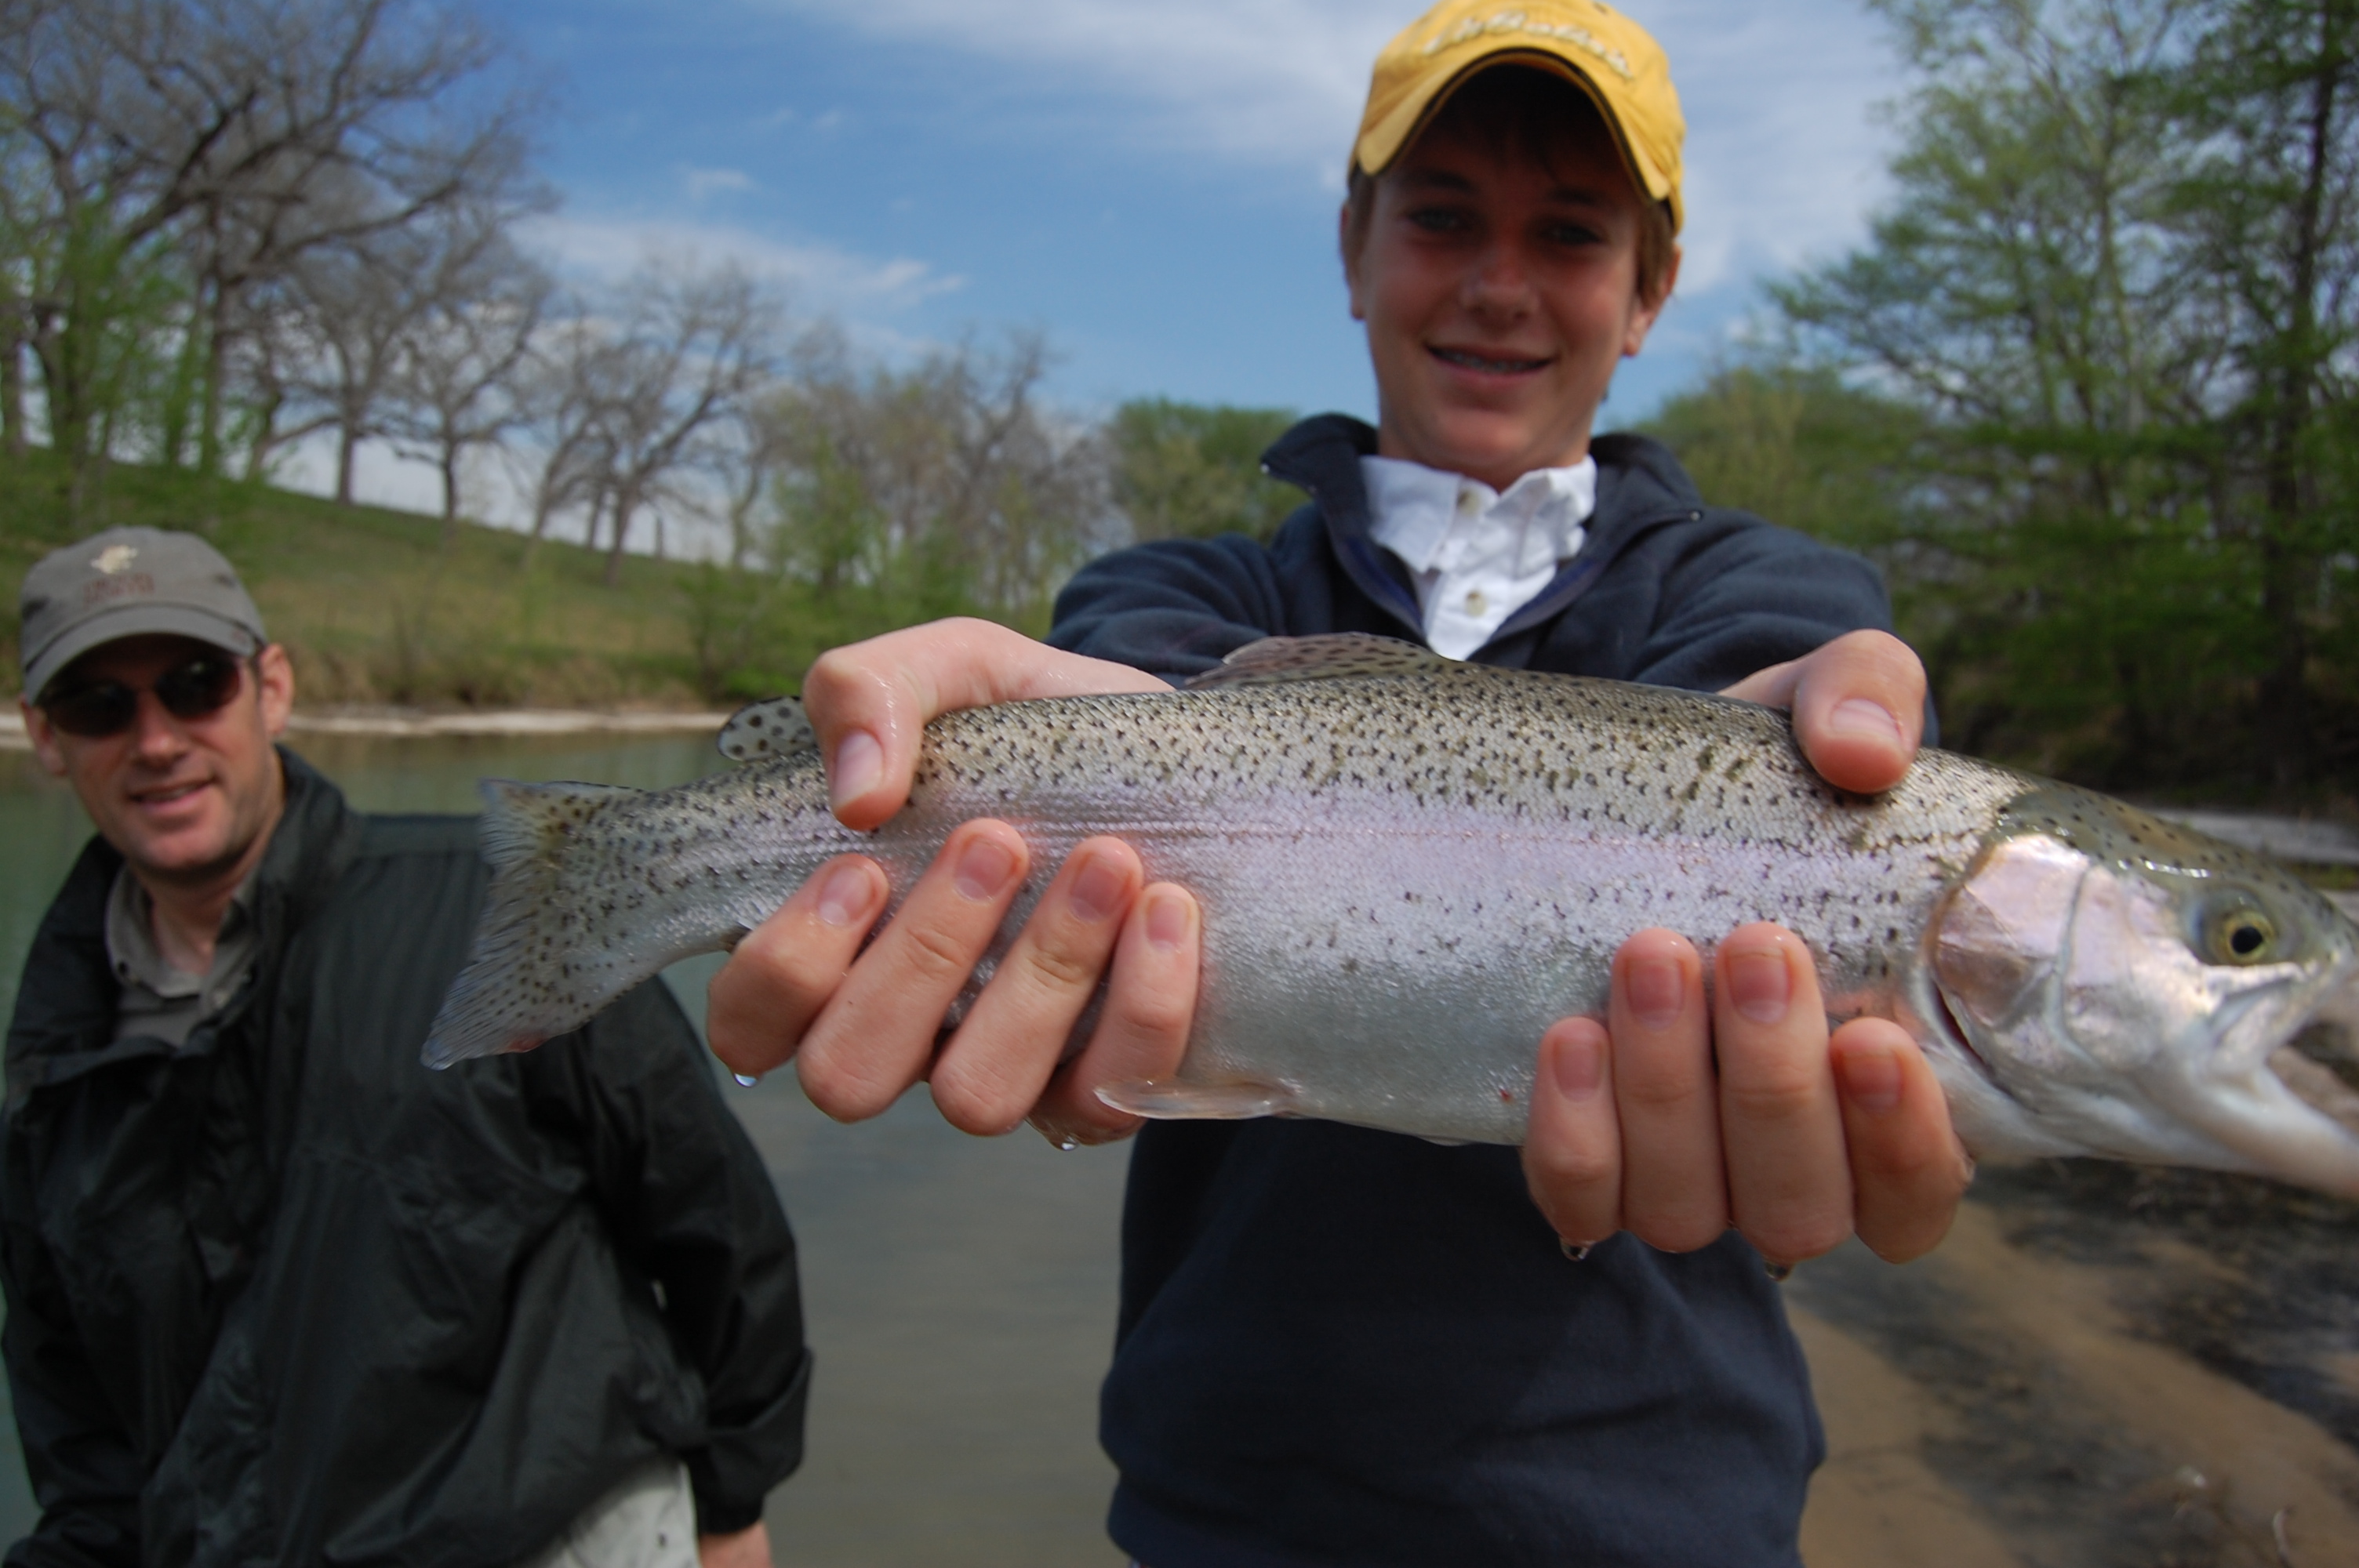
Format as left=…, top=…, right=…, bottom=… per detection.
left=7, top=747, right=361, bottom=1113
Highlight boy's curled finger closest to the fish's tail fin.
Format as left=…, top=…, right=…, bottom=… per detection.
left=705, top=856, right=887, bottom=1075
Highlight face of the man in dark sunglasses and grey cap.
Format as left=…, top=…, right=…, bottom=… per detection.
left=24, top=637, right=295, bottom=887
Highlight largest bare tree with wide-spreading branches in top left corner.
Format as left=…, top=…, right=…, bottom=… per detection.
left=0, top=0, right=540, bottom=483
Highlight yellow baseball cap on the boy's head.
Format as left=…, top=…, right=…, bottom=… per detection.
left=1352, top=0, right=1687, bottom=234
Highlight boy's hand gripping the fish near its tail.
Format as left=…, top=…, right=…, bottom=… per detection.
left=705, top=620, right=1203, bottom=1144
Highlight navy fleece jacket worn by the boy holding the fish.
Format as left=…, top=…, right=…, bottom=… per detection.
left=1050, top=415, right=1889, bottom=1568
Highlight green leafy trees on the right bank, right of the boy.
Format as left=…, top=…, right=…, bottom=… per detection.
left=1654, top=0, right=2359, bottom=802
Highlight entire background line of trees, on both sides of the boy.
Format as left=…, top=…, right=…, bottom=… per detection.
left=23, top=0, right=2359, bottom=800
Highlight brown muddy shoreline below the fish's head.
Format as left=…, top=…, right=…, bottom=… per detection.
left=1786, top=1160, right=2359, bottom=1568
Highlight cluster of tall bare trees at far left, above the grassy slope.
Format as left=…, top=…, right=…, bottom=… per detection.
left=0, top=0, right=545, bottom=514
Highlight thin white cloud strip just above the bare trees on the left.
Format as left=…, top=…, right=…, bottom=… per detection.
left=526, top=215, right=965, bottom=314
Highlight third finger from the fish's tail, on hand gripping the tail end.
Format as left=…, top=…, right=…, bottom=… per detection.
left=927, top=840, right=1147, bottom=1137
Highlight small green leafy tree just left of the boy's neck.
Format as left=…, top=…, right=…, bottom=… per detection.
left=1107, top=398, right=1302, bottom=543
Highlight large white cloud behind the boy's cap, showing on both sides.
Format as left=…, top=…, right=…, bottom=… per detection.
left=753, top=0, right=1896, bottom=292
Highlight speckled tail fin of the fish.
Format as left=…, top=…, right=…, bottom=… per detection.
left=422, top=778, right=639, bottom=1068
